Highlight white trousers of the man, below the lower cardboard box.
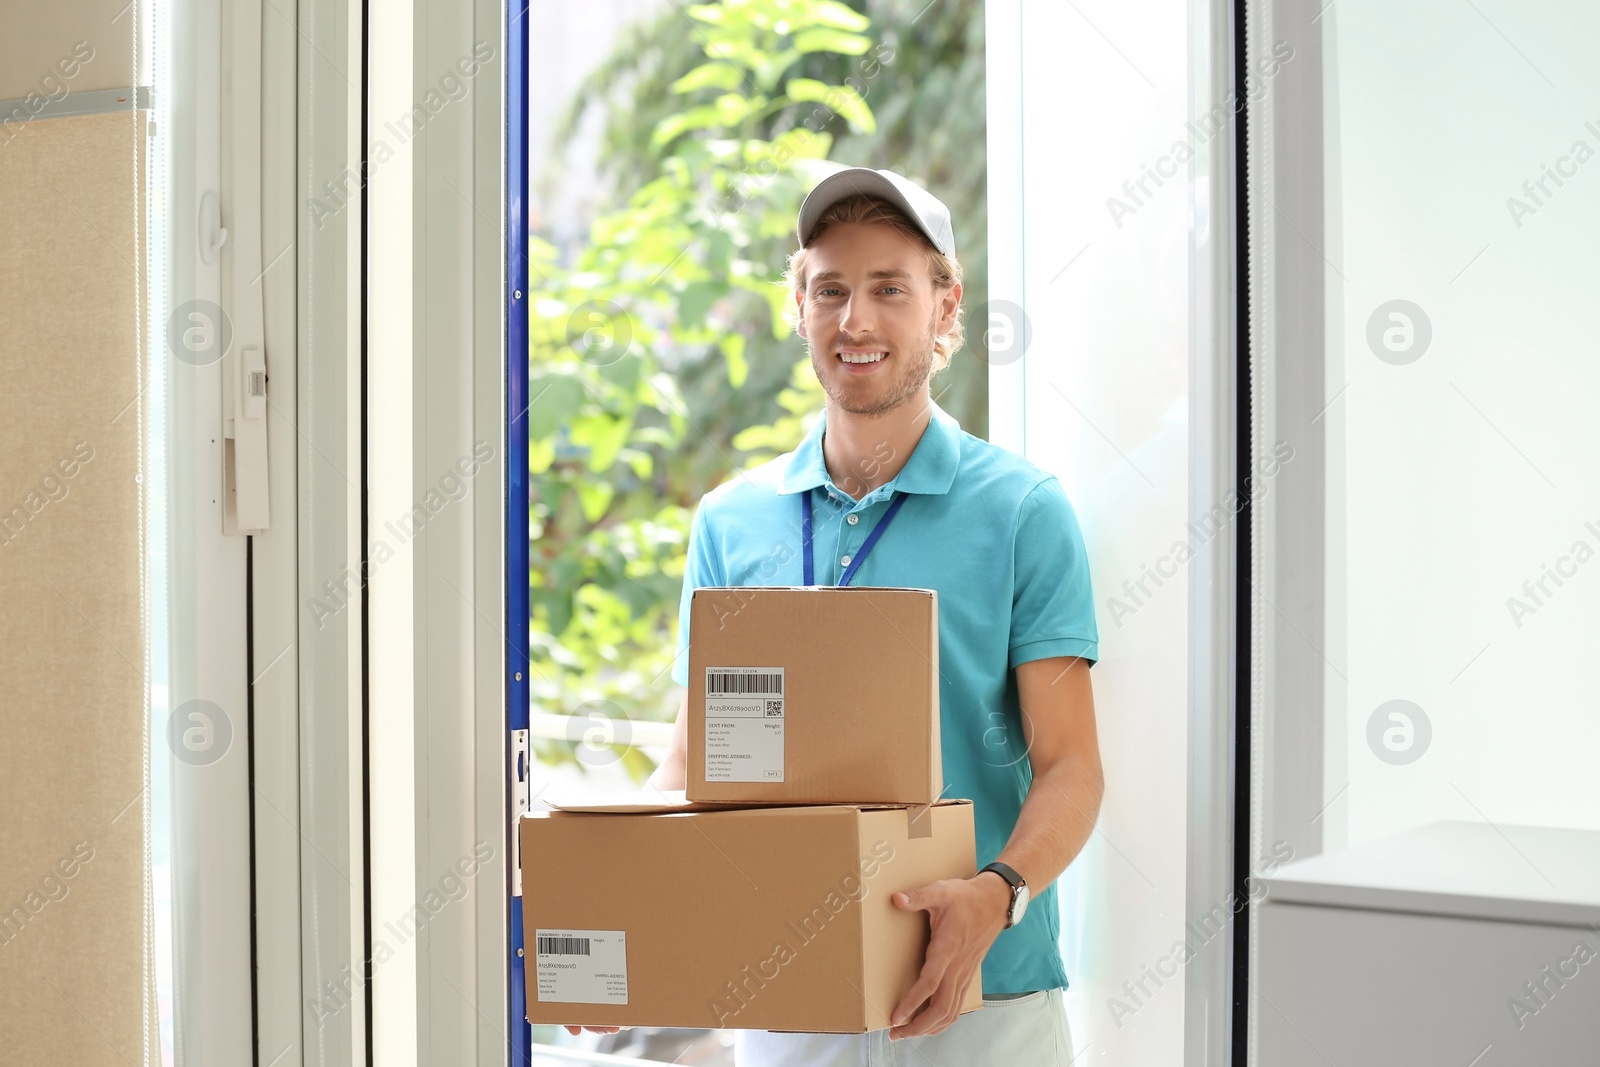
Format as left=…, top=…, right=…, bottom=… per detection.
left=733, top=989, right=1072, bottom=1067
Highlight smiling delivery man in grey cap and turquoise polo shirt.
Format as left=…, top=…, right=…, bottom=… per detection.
left=653, top=168, right=1104, bottom=1067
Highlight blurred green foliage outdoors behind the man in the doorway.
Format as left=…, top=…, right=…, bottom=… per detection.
left=526, top=0, right=987, bottom=777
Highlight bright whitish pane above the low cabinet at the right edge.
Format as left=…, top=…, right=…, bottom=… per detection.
left=1318, top=0, right=1600, bottom=849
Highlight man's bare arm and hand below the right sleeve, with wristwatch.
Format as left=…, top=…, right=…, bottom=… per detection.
left=890, top=656, right=1106, bottom=1038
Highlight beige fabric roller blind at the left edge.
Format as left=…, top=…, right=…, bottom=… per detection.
left=0, top=110, right=158, bottom=1064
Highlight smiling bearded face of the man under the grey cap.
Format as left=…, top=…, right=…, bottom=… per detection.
left=795, top=222, right=960, bottom=414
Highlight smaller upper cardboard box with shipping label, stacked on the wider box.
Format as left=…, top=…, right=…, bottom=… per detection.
left=686, top=585, right=944, bottom=805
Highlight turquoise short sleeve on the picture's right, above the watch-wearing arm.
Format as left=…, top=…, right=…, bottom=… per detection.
left=1008, top=477, right=1099, bottom=669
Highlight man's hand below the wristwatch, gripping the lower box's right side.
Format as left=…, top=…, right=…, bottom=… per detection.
left=890, top=872, right=1011, bottom=1040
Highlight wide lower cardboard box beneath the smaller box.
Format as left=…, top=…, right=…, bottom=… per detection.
left=518, top=800, right=982, bottom=1033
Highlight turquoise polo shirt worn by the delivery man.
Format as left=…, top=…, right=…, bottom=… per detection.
left=672, top=405, right=1099, bottom=995
